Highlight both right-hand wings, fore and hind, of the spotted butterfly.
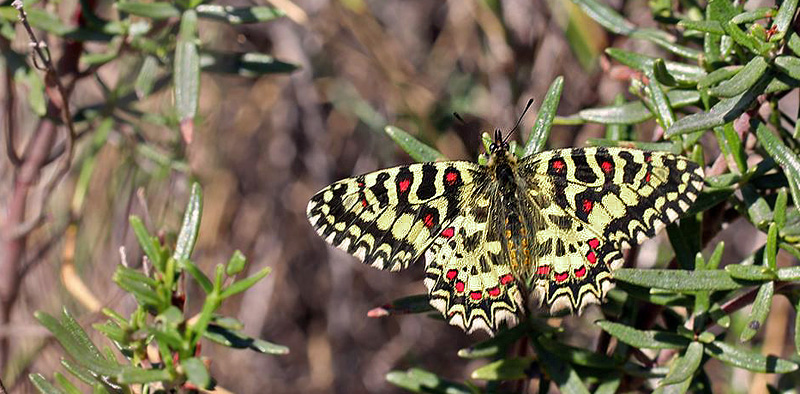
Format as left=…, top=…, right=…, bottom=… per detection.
left=520, top=147, right=703, bottom=312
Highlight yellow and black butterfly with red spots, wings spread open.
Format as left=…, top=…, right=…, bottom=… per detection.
left=307, top=130, right=703, bottom=334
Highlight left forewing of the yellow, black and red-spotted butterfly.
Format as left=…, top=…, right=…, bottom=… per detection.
left=307, top=161, right=481, bottom=271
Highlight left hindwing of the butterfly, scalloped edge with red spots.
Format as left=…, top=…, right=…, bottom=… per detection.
left=425, top=187, right=524, bottom=333
